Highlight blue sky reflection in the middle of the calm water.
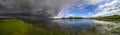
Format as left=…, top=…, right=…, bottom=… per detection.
left=53, top=19, right=95, bottom=31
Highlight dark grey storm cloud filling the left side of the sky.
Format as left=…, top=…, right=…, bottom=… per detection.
left=0, top=0, right=79, bottom=18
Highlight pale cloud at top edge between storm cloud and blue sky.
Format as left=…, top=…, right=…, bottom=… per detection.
left=76, top=0, right=104, bottom=9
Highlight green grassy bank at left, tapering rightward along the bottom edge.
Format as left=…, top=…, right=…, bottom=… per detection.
left=0, top=19, right=69, bottom=35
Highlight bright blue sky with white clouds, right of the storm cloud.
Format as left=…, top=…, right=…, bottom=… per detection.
left=56, top=0, right=120, bottom=18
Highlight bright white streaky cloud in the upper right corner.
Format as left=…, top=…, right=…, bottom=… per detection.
left=92, top=0, right=120, bottom=17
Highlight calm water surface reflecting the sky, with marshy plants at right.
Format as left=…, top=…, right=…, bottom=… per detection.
left=25, top=19, right=120, bottom=35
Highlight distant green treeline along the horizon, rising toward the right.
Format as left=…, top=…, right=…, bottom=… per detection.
left=61, top=15, right=120, bottom=21
